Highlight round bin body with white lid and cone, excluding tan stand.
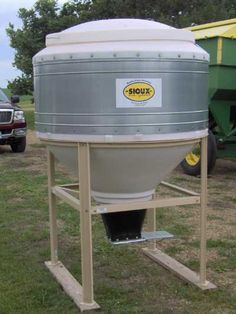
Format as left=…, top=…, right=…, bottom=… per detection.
left=33, top=19, right=208, bottom=243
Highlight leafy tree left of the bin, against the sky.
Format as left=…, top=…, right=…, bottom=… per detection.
left=6, top=0, right=78, bottom=94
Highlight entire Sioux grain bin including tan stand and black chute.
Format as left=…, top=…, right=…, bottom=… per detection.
left=33, top=19, right=215, bottom=311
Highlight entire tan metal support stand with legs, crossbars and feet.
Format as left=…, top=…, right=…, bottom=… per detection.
left=45, top=137, right=216, bottom=311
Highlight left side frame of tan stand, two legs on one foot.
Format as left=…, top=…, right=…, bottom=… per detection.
left=45, top=143, right=100, bottom=312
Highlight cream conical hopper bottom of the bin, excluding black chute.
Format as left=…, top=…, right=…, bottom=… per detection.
left=49, top=142, right=192, bottom=203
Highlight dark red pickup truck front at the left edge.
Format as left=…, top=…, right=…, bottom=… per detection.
left=0, top=89, right=26, bottom=153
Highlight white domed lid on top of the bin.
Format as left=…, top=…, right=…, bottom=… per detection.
left=46, top=19, right=195, bottom=46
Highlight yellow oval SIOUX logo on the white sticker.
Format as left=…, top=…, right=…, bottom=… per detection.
left=123, top=81, right=155, bottom=102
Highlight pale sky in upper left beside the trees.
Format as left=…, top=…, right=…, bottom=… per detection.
left=0, top=0, right=67, bottom=88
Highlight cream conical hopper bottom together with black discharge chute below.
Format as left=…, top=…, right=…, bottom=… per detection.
left=49, top=142, right=195, bottom=243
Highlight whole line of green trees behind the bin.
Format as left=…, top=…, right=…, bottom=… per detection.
left=6, top=0, right=236, bottom=94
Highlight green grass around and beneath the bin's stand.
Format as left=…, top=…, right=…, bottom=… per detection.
left=0, top=148, right=236, bottom=314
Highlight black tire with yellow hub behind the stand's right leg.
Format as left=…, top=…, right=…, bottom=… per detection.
left=180, top=130, right=216, bottom=176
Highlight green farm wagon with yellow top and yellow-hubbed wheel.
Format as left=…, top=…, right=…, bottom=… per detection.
left=181, top=19, right=236, bottom=175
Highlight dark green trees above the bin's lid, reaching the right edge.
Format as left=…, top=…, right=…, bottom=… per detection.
left=68, top=0, right=236, bottom=28
